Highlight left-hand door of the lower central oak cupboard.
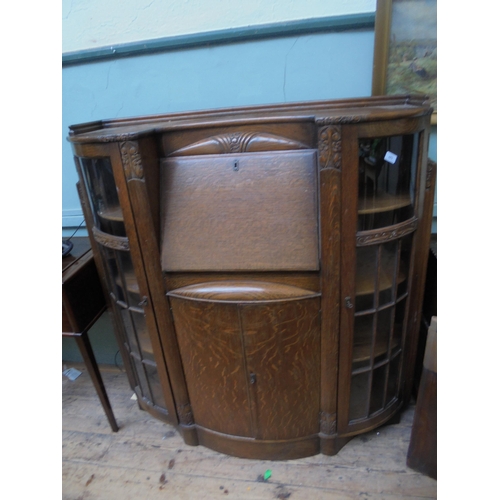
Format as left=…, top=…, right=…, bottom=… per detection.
left=170, top=297, right=253, bottom=437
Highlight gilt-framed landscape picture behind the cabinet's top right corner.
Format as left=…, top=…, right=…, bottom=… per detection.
left=372, top=0, right=437, bottom=124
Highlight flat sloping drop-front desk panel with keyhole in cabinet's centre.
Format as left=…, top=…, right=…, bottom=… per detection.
left=161, top=150, right=319, bottom=271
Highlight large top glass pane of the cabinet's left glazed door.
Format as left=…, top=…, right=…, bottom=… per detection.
left=79, top=158, right=126, bottom=236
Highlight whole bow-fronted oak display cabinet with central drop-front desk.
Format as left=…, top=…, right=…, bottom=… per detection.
left=69, top=96, right=435, bottom=459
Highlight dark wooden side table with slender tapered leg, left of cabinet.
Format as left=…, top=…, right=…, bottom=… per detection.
left=62, top=238, right=118, bottom=432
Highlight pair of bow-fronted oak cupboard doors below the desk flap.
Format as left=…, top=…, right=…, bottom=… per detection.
left=170, top=297, right=320, bottom=440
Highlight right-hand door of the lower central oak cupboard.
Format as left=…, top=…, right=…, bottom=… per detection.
left=240, top=297, right=320, bottom=440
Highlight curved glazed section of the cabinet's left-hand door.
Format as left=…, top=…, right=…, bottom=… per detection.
left=75, top=151, right=177, bottom=423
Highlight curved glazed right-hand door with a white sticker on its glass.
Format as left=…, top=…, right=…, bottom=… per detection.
left=339, top=122, right=427, bottom=434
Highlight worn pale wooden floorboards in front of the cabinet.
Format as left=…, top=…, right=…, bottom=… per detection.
left=62, top=363, right=437, bottom=500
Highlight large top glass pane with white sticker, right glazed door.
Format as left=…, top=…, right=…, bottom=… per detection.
left=358, top=134, right=418, bottom=231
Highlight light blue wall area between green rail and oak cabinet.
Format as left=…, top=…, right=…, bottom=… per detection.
left=62, top=29, right=374, bottom=235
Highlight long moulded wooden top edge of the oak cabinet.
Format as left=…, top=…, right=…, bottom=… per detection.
left=68, top=95, right=432, bottom=143
